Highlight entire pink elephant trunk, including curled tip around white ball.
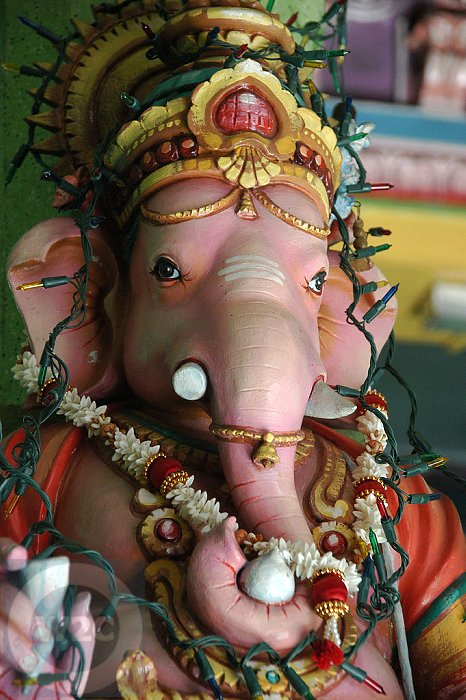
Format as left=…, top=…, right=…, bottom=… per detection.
left=188, top=294, right=325, bottom=652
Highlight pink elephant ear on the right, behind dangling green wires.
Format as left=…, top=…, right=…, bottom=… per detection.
left=318, top=251, right=397, bottom=389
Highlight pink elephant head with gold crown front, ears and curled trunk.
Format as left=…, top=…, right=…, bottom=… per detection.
left=6, top=34, right=395, bottom=660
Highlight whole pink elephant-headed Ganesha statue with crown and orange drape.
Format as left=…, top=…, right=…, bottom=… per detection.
left=0, top=0, right=466, bottom=700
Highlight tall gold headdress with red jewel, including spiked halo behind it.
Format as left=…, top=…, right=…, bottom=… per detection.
left=11, top=0, right=342, bottom=237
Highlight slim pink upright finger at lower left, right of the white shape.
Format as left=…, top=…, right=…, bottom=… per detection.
left=60, top=593, right=95, bottom=693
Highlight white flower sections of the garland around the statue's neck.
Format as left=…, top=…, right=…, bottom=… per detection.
left=12, top=351, right=388, bottom=595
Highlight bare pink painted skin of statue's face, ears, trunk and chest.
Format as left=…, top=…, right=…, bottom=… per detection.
left=0, top=180, right=402, bottom=698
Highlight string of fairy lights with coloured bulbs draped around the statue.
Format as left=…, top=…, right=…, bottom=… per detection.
left=0, top=0, right=458, bottom=700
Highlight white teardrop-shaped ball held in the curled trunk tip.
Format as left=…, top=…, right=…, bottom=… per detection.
left=239, top=549, right=295, bottom=605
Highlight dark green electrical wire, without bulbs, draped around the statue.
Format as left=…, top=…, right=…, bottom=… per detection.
left=0, top=0, right=464, bottom=699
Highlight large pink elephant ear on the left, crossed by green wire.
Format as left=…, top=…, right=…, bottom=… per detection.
left=8, top=218, right=124, bottom=398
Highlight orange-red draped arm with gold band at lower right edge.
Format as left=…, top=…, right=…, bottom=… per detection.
left=398, top=477, right=466, bottom=700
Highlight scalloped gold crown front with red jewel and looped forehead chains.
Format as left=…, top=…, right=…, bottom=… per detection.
left=104, top=59, right=341, bottom=230
